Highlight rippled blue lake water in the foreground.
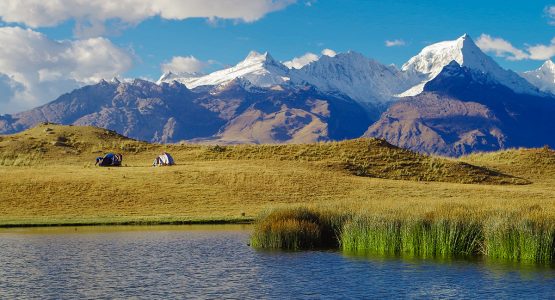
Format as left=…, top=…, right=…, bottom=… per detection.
left=0, top=226, right=555, bottom=299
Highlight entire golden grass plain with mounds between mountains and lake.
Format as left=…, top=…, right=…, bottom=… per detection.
left=0, top=124, right=555, bottom=226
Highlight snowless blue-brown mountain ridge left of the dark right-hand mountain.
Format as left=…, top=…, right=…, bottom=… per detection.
left=0, top=80, right=371, bottom=143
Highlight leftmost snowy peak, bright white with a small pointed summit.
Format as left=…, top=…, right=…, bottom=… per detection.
left=158, top=51, right=289, bottom=89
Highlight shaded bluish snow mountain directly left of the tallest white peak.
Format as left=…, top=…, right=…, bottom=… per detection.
left=290, top=51, right=410, bottom=104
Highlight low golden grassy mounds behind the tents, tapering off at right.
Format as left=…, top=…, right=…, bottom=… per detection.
left=0, top=123, right=527, bottom=184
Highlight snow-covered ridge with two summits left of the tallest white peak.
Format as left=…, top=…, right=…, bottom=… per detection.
left=158, top=51, right=411, bottom=104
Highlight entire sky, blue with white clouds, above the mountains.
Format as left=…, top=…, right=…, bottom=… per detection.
left=0, top=0, right=555, bottom=114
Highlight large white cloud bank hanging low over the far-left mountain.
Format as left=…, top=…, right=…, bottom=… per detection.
left=0, top=27, right=133, bottom=114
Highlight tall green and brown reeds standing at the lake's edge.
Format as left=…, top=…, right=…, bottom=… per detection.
left=252, top=207, right=555, bottom=263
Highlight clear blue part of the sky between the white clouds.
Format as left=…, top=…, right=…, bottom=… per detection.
left=35, top=0, right=555, bottom=78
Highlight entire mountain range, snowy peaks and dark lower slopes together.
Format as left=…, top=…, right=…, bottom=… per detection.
left=0, top=35, right=555, bottom=156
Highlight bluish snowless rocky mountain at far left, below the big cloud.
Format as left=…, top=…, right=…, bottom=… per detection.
left=0, top=80, right=224, bottom=142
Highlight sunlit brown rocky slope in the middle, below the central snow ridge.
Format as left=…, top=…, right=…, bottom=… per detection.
left=203, top=87, right=372, bottom=143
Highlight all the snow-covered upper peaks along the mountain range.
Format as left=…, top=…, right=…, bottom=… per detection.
left=158, top=34, right=544, bottom=107
